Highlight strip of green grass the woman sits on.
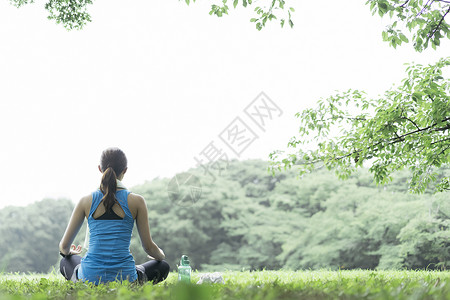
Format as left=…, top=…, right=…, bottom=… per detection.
left=0, top=270, right=450, bottom=300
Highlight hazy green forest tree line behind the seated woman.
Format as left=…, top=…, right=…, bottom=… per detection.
left=0, top=160, right=450, bottom=272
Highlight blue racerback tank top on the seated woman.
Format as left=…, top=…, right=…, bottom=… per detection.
left=78, top=189, right=137, bottom=284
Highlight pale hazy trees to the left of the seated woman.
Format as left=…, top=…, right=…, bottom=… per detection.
left=0, top=199, right=73, bottom=273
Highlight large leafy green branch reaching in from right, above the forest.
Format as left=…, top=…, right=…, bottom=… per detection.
left=269, top=57, right=450, bottom=192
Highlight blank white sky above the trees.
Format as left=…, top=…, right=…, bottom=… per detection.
left=0, top=0, right=450, bottom=207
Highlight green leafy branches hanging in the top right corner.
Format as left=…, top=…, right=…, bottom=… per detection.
left=366, top=0, right=450, bottom=52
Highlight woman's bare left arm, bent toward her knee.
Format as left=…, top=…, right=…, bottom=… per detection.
left=59, top=195, right=92, bottom=255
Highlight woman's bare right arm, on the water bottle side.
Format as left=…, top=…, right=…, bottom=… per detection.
left=134, top=194, right=166, bottom=260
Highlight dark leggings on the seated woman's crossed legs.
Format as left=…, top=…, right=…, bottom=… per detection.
left=59, top=255, right=170, bottom=284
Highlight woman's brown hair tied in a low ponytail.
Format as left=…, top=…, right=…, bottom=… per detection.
left=100, top=147, right=127, bottom=211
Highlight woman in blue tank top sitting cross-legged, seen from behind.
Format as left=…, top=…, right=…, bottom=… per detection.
left=59, top=148, right=169, bottom=284
